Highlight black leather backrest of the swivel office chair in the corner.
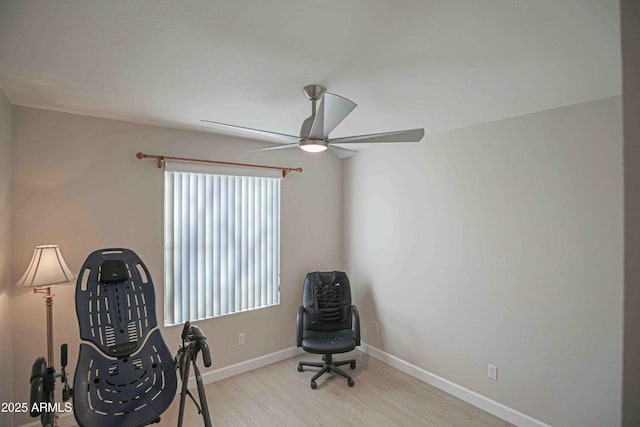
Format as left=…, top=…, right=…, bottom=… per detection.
left=302, top=271, right=351, bottom=331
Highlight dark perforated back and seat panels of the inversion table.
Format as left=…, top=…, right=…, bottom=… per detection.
left=73, top=249, right=177, bottom=427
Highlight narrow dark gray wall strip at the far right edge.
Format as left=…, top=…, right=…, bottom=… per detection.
left=621, top=0, right=640, bottom=427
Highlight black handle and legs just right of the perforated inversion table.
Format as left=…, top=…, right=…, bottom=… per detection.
left=175, top=322, right=211, bottom=427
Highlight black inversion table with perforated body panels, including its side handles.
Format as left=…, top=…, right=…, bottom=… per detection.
left=29, top=249, right=211, bottom=427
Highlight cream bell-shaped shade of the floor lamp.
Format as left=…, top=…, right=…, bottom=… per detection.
left=16, top=245, right=76, bottom=287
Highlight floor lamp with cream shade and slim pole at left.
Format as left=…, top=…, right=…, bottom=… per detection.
left=16, top=245, right=76, bottom=426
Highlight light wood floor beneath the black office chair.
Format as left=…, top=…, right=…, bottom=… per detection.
left=161, top=351, right=512, bottom=427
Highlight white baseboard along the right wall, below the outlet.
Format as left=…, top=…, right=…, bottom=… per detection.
left=360, top=343, right=551, bottom=427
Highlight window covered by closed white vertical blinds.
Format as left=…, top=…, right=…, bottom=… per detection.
left=164, top=163, right=280, bottom=325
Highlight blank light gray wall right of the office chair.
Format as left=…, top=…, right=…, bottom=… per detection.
left=344, top=97, right=623, bottom=427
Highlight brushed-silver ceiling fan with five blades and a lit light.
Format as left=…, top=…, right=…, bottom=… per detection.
left=201, top=85, right=424, bottom=159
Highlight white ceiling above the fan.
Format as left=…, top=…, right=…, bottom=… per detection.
left=0, top=0, right=621, bottom=144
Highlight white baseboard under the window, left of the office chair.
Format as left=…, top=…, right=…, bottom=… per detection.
left=20, top=347, right=303, bottom=427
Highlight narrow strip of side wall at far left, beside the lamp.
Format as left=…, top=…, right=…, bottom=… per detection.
left=0, top=90, right=13, bottom=419
